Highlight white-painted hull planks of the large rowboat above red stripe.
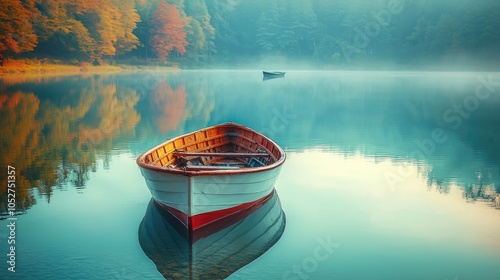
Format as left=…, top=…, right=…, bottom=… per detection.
left=141, top=166, right=281, bottom=226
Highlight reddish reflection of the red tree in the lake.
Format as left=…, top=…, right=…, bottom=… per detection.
left=149, top=82, right=187, bottom=133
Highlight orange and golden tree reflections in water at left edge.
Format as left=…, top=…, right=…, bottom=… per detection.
left=0, top=76, right=140, bottom=214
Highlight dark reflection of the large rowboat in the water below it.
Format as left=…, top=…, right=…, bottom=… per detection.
left=139, top=190, right=285, bottom=279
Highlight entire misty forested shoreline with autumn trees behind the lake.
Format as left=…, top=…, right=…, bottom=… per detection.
left=0, top=0, right=500, bottom=69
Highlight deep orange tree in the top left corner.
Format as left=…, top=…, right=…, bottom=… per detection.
left=0, top=0, right=37, bottom=53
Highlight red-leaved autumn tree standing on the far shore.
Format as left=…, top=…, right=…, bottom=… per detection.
left=150, top=1, right=188, bottom=61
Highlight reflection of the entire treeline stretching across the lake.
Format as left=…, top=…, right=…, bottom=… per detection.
left=0, top=71, right=500, bottom=215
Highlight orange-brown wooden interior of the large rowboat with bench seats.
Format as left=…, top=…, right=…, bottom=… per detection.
left=144, top=124, right=284, bottom=171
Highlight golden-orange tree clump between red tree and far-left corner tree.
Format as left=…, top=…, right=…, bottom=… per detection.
left=33, top=0, right=140, bottom=60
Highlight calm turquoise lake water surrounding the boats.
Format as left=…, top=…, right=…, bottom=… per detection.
left=0, top=71, right=500, bottom=280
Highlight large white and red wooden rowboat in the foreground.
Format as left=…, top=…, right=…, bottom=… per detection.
left=137, top=123, right=286, bottom=230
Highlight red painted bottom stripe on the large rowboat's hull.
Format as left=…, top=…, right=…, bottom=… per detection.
left=157, top=190, right=274, bottom=231
